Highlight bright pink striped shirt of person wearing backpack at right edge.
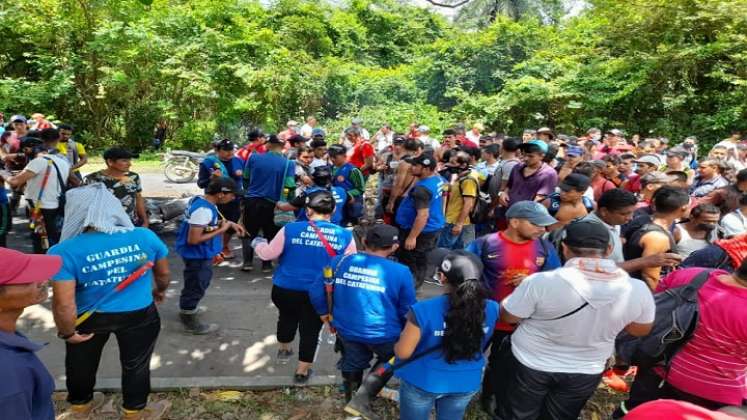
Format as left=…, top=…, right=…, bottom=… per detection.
left=657, top=268, right=747, bottom=405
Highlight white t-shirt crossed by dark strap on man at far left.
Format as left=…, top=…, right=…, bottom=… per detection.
left=23, top=154, right=70, bottom=210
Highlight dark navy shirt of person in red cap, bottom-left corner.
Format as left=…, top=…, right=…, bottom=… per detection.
left=0, top=331, right=54, bottom=420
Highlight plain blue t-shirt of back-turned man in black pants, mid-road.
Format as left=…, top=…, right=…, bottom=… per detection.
left=244, top=152, right=296, bottom=202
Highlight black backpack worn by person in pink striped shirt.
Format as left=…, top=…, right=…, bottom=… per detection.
left=615, top=269, right=712, bottom=365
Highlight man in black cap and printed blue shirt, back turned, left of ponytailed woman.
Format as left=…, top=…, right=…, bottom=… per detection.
left=309, top=224, right=415, bottom=401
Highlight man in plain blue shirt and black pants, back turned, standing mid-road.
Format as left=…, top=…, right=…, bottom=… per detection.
left=241, top=134, right=296, bottom=272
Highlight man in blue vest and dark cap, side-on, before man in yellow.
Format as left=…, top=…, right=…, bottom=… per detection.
left=395, top=153, right=446, bottom=287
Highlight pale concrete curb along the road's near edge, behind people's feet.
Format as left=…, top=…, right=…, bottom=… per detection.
left=55, top=375, right=340, bottom=392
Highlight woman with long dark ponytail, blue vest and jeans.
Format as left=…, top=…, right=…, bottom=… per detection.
left=394, top=251, right=498, bottom=420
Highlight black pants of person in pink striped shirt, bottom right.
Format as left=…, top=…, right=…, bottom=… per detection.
left=612, top=366, right=728, bottom=419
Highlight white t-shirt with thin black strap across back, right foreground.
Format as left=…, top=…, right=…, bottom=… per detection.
left=503, top=258, right=656, bottom=375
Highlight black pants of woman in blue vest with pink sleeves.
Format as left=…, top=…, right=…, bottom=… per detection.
left=272, top=285, right=323, bottom=363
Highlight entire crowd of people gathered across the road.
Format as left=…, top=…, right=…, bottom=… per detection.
left=0, top=115, right=747, bottom=420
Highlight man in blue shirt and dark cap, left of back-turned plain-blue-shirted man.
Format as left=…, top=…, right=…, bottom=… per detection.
left=197, top=139, right=244, bottom=260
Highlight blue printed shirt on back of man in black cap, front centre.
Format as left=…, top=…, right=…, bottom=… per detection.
left=309, top=253, right=416, bottom=344
